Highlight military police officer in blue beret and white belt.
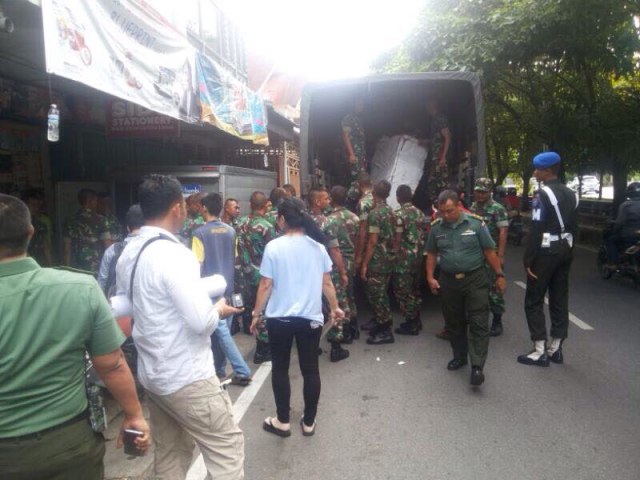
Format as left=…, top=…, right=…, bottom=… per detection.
left=518, top=152, right=578, bottom=367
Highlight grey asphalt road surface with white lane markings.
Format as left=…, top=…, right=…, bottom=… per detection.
left=198, top=244, right=640, bottom=480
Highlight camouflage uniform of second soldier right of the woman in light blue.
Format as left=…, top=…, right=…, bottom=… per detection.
left=327, top=207, right=360, bottom=340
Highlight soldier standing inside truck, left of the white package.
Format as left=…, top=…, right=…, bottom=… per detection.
left=342, top=99, right=367, bottom=201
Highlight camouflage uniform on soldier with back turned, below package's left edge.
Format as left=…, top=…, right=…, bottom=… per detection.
left=366, top=201, right=396, bottom=327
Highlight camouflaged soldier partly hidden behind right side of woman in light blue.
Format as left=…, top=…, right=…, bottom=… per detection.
left=308, top=188, right=349, bottom=362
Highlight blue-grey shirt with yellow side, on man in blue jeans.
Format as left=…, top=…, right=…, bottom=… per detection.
left=191, top=220, right=236, bottom=297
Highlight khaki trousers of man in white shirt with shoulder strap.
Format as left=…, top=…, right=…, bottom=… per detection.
left=147, top=377, right=244, bottom=480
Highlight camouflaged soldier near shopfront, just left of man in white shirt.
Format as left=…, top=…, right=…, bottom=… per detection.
left=64, top=188, right=113, bottom=273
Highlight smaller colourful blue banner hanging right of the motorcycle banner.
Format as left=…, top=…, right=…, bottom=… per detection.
left=196, top=54, right=269, bottom=145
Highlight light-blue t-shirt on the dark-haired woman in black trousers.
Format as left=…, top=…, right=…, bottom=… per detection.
left=260, top=235, right=332, bottom=323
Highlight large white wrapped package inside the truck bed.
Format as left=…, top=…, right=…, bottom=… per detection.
left=371, top=135, right=427, bottom=209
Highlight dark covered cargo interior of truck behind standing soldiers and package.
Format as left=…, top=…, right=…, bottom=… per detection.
left=300, top=72, right=486, bottom=207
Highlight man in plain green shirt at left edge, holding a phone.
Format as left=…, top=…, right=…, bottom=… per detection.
left=0, top=194, right=150, bottom=480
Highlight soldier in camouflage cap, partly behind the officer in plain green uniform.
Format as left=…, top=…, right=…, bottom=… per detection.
left=469, top=178, right=509, bottom=337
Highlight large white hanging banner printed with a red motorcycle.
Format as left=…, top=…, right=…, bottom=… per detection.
left=42, top=0, right=200, bottom=123
